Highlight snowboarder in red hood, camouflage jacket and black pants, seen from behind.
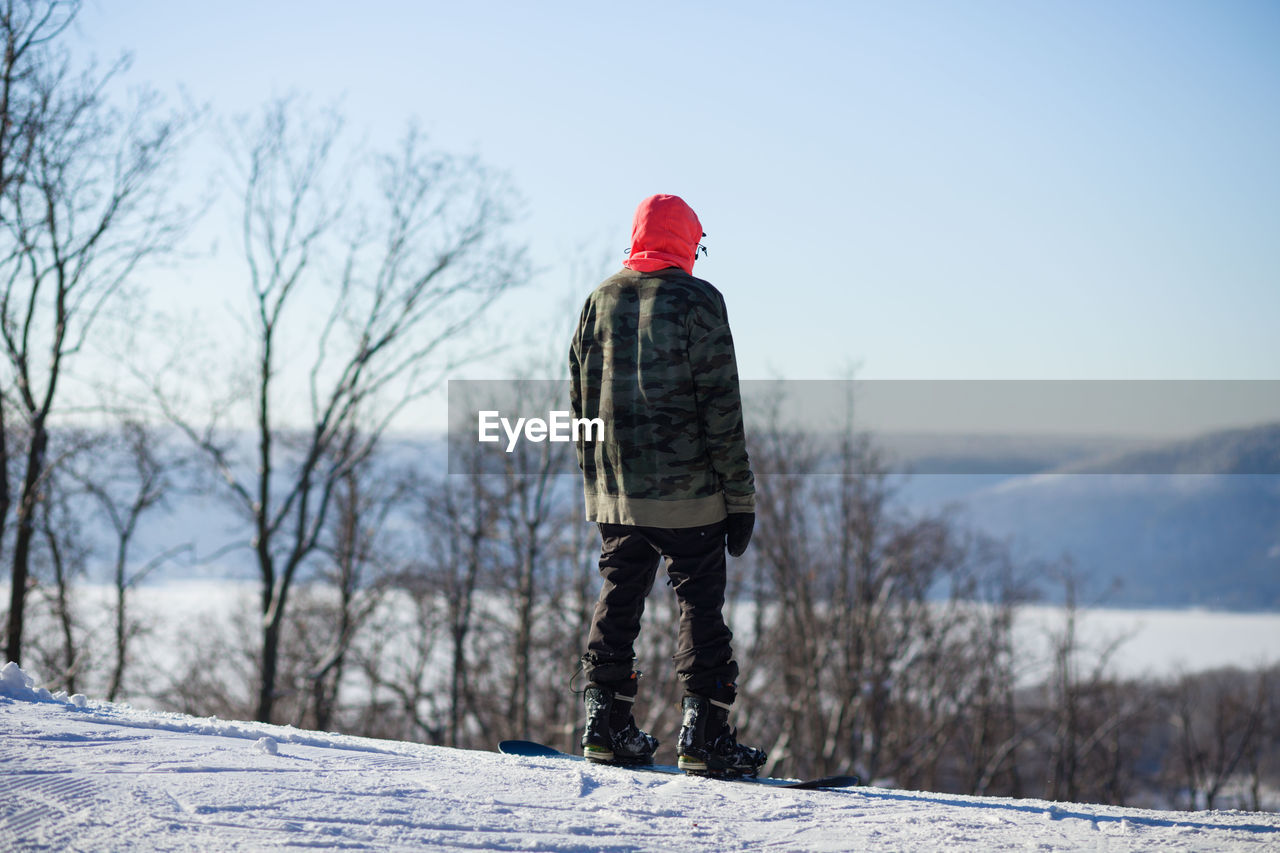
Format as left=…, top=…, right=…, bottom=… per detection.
left=570, top=195, right=765, bottom=775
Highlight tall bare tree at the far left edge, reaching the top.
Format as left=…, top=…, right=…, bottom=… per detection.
left=0, top=0, right=188, bottom=661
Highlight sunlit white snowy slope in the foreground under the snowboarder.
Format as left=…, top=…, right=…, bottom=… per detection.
left=0, top=663, right=1280, bottom=852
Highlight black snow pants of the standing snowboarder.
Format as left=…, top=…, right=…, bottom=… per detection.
left=582, top=521, right=737, bottom=703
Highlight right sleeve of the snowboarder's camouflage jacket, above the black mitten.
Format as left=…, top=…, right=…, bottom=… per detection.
left=689, top=298, right=755, bottom=512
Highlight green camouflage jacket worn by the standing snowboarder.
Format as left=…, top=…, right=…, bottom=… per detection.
left=570, top=266, right=755, bottom=528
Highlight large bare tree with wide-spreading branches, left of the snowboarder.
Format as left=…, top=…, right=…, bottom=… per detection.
left=153, top=100, right=524, bottom=720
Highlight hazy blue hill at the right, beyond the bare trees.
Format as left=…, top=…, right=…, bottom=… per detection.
left=890, top=424, right=1280, bottom=610
